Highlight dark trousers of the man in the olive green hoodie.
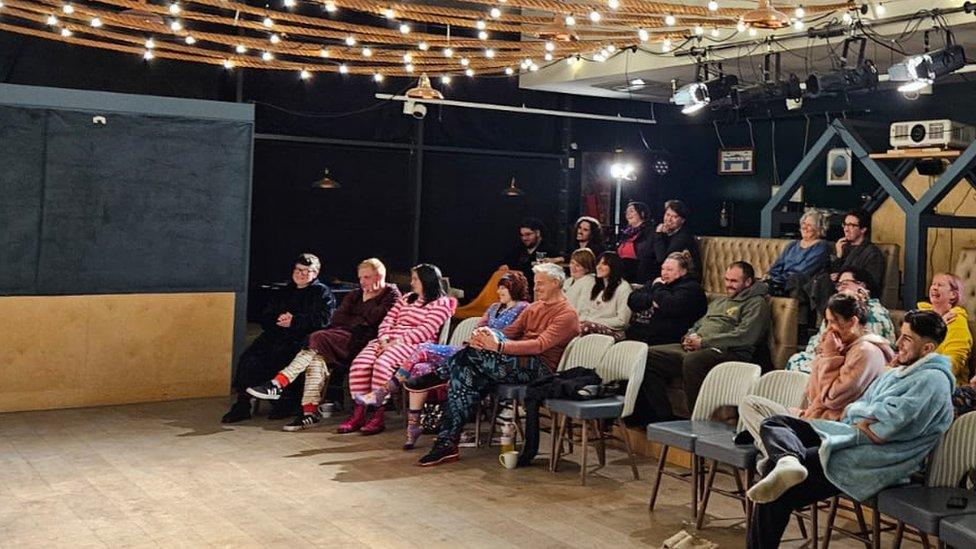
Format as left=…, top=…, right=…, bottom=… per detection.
left=628, top=343, right=752, bottom=425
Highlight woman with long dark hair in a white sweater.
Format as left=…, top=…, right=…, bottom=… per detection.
left=577, top=252, right=633, bottom=341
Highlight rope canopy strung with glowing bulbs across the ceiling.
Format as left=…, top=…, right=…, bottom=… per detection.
left=0, top=0, right=853, bottom=80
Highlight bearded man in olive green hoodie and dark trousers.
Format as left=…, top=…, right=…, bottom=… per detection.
left=628, top=261, right=770, bottom=425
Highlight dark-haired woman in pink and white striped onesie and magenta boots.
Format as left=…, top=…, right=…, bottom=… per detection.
left=337, top=263, right=457, bottom=435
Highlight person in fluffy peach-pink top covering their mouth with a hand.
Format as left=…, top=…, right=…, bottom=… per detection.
left=739, top=293, right=894, bottom=464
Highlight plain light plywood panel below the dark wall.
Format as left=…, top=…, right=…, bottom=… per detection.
left=0, top=293, right=234, bottom=412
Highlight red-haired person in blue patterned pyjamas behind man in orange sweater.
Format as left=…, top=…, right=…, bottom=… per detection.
left=356, top=271, right=529, bottom=450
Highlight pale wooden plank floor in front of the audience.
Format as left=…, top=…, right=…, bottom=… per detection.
left=0, top=399, right=896, bottom=548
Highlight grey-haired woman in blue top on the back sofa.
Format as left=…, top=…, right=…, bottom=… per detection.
left=765, top=210, right=830, bottom=297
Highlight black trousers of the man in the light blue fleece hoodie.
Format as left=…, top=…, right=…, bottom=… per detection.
left=747, top=416, right=840, bottom=549
